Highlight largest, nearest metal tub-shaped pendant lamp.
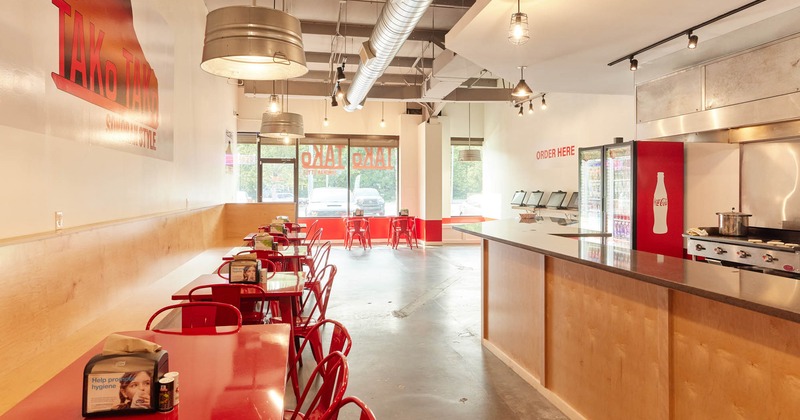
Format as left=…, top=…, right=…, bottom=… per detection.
left=200, top=2, right=308, bottom=80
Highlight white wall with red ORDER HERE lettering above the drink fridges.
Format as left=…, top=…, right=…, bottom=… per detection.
left=483, top=93, right=635, bottom=218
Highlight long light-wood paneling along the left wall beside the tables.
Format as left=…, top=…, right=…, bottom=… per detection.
left=0, top=206, right=222, bottom=408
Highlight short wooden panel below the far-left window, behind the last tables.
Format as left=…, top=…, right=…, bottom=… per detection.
left=223, top=203, right=296, bottom=238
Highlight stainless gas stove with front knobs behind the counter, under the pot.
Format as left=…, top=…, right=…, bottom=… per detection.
left=684, top=227, right=800, bottom=278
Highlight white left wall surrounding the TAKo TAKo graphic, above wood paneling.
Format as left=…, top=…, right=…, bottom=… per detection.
left=0, top=0, right=236, bottom=238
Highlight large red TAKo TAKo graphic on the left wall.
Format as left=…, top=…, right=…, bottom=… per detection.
left=52, top=0, right=159, bottom=150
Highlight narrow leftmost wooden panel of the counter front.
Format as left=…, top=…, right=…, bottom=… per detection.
left=485, top=242, right=544, bottom=381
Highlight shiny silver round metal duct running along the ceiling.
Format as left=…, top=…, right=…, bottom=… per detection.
left=344, top=0, right=432, bottom=112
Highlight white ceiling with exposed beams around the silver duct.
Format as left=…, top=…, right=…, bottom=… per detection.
left=205, top=0, right=798, bottom=103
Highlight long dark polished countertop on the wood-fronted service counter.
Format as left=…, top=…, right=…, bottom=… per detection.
left=453, top=219, right=800, bottom=322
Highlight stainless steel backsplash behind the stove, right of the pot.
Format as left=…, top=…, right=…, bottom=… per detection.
left=740, top=137, right=800, bottom=230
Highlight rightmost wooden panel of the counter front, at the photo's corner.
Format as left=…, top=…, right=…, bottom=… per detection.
left=672, top=292, right=800, bottom=419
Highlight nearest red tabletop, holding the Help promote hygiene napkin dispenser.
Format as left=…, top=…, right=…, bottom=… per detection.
left=3, top=324, right=294, bottom=420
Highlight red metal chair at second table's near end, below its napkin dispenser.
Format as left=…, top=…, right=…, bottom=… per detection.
left=189, top=284, right=268, bottom=325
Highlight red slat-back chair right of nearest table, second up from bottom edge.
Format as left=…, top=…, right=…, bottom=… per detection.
left=283, top=351, right=350, bottom=420
